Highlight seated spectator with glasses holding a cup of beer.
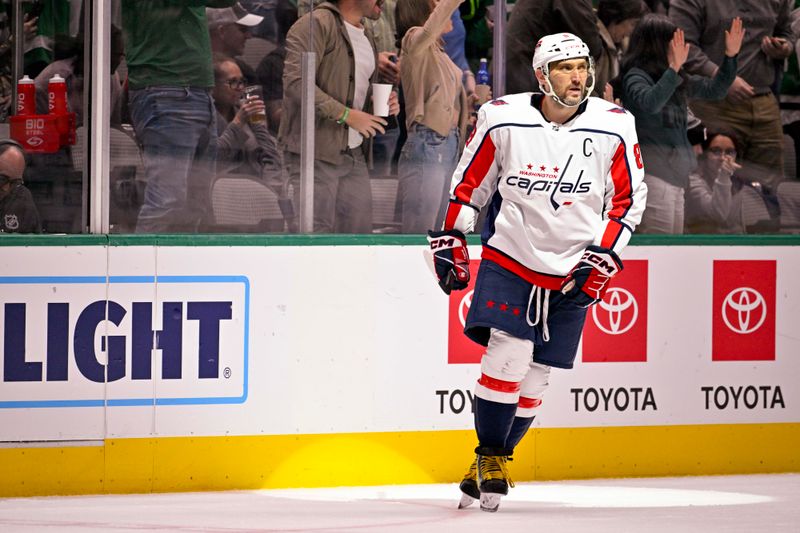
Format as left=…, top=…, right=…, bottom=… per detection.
left=213, top=56, right=288, bottom=199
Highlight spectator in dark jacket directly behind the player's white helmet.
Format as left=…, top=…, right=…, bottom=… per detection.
left=506, top=0, right=603, bottom=94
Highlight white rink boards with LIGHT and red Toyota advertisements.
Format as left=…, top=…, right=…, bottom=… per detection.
left=0, top=239, right=800, bottom=441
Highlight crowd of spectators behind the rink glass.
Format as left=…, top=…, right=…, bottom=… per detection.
left=0, top=0, right=800, bottom=234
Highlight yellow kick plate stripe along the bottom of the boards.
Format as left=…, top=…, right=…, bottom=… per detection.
left=0, top=423, right=800, bottom=497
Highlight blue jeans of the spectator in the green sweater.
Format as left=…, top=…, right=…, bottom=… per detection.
left=130, top=87, right=217, bottom=233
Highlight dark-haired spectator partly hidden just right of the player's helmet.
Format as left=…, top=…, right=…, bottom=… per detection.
left=592, top=0, right=647, bottom=102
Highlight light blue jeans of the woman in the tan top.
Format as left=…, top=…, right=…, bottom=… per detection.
left=397, top=123, right=458, bottom=233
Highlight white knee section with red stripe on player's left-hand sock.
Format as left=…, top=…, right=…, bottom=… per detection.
left=475, top=329, right=533, bottom=403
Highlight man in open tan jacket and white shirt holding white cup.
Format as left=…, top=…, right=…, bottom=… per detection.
left=278, top=0, right=399, bottom=233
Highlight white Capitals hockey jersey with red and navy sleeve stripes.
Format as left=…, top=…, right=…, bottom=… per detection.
left=444, top=93, right=647, bottom=289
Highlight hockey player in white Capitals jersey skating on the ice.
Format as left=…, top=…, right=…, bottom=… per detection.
left=428, top=33, right=647, bottom=511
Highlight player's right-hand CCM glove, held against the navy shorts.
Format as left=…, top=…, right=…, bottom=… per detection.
left=561, top=245, right=622, bottom=307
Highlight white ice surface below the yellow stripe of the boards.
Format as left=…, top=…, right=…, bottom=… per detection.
left=0, top=474, right=800, bottom=533
